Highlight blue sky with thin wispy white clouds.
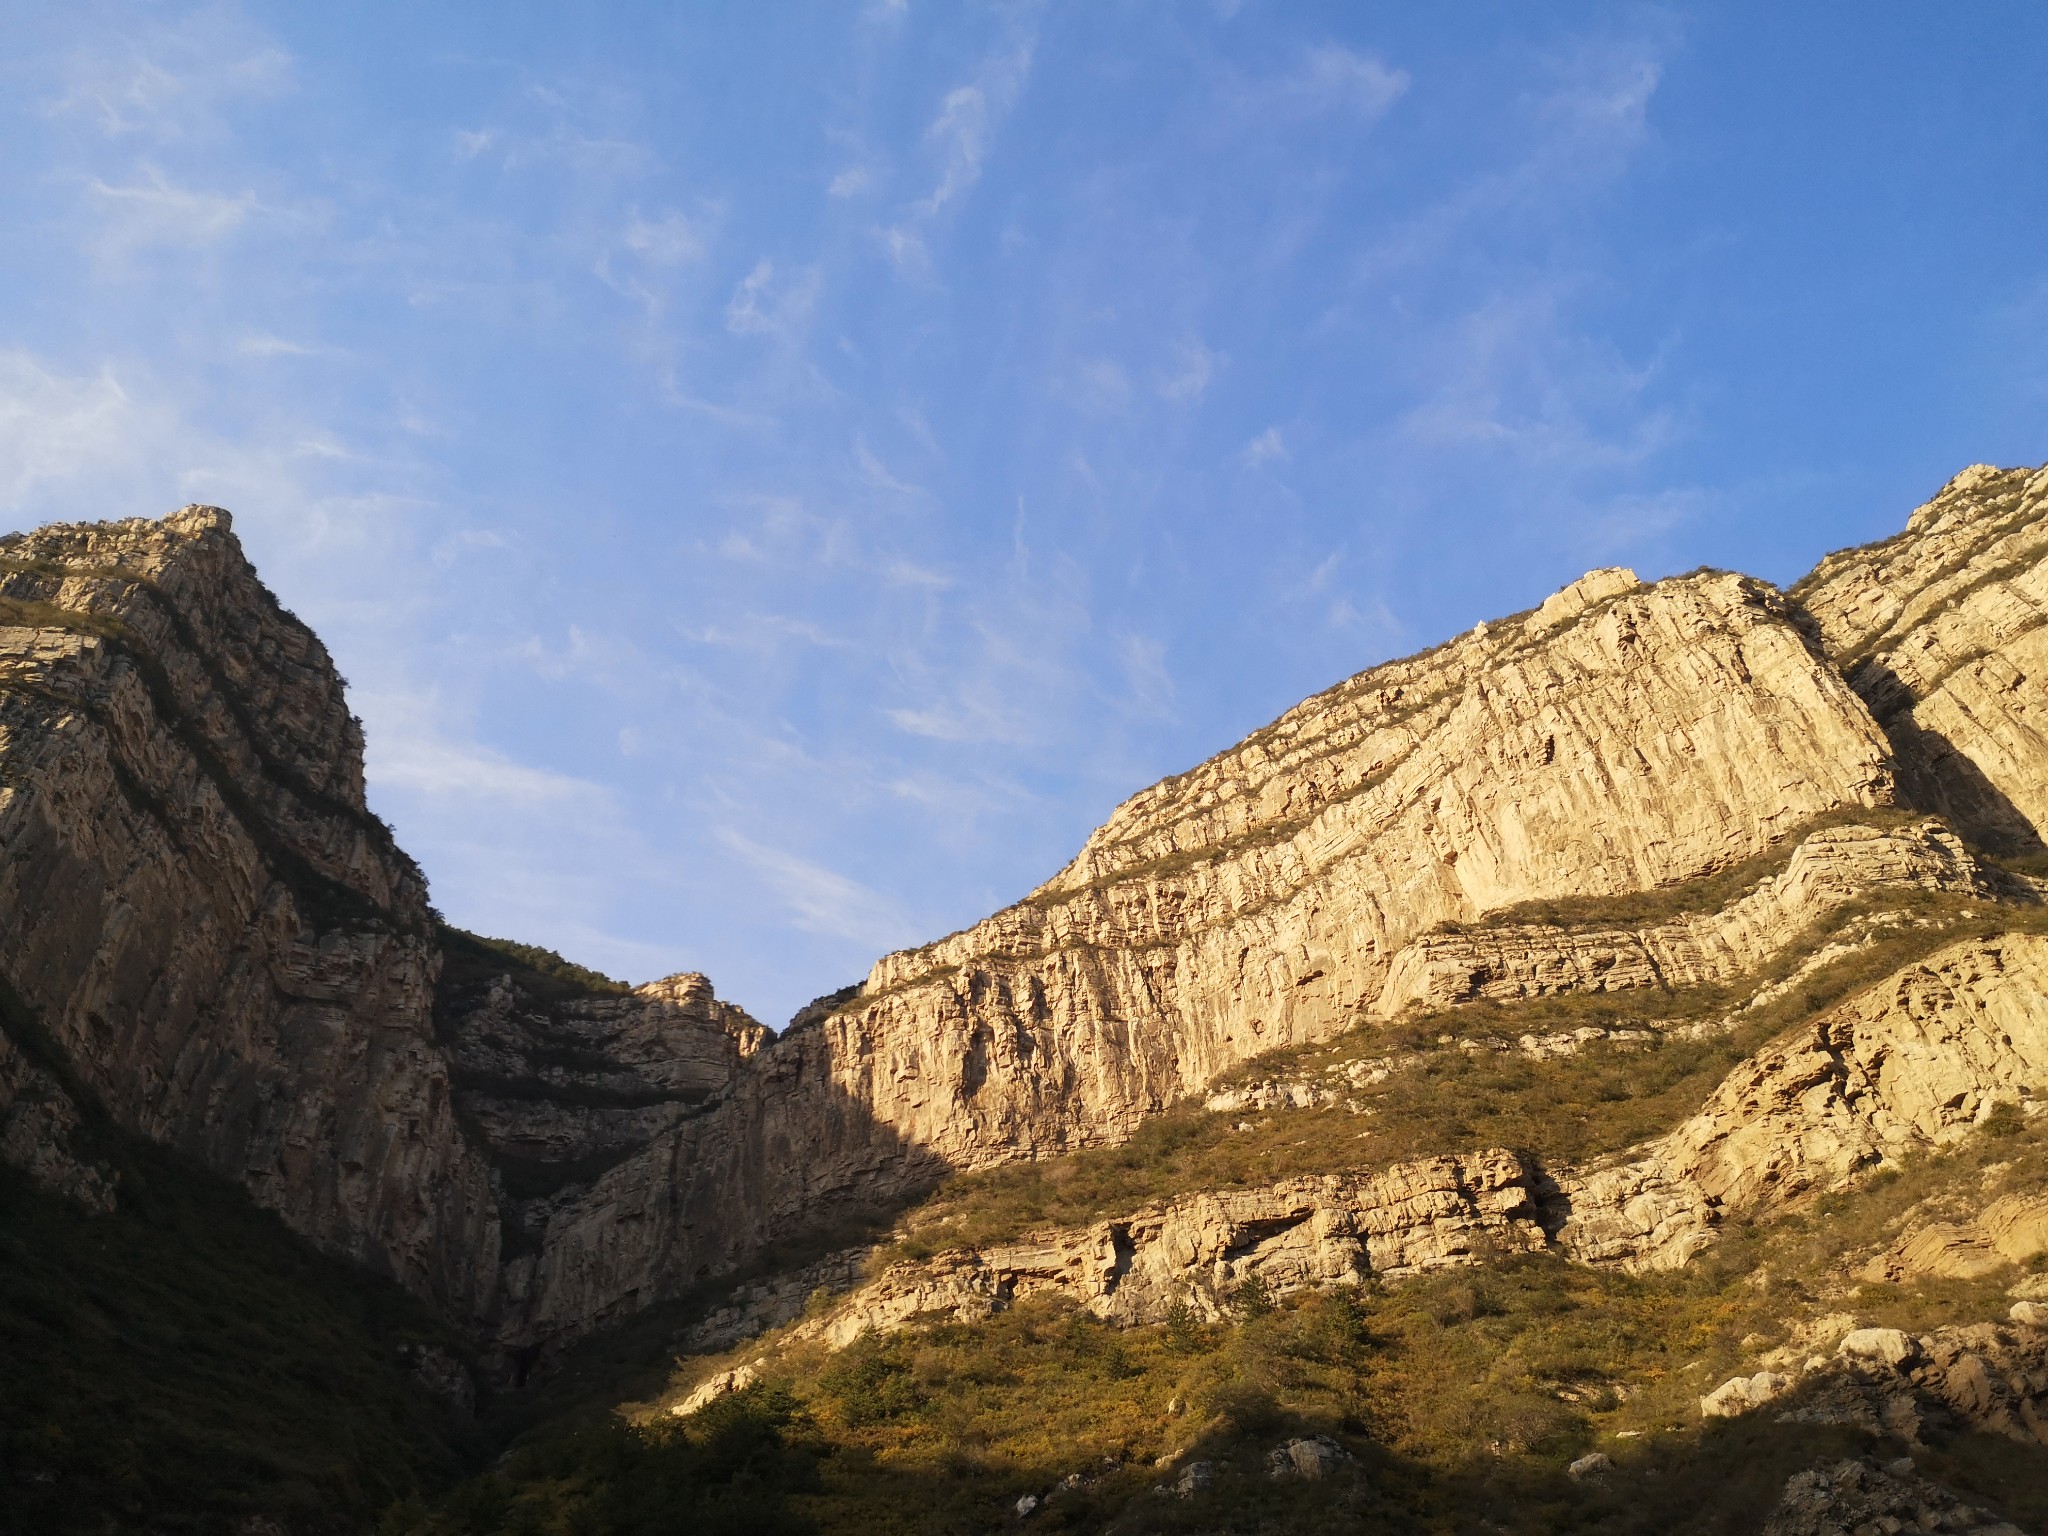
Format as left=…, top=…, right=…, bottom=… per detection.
left=0, top=0, right=2048, bottom=1022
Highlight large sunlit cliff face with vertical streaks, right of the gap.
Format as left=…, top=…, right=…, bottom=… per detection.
left=821, top=571, right=1890, bottom=1167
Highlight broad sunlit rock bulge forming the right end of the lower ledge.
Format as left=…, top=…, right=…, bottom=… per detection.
left=1559, top=934, right=2048, bottom=1270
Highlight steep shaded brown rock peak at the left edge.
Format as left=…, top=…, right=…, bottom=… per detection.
left=0, top=508, right=498, bottom=1319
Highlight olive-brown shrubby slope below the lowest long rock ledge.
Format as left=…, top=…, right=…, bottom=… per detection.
left=411, top=1120, right=2048, bottom=1536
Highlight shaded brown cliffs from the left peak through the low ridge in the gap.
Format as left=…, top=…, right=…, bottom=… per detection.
left=0, top=508, right=790, bottom=1343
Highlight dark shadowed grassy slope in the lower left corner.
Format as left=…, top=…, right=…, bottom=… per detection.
left=0, top=1130, right=469, bottom=1536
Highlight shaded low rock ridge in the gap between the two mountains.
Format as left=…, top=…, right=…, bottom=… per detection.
left=438, top=958, right=884, bottom=1354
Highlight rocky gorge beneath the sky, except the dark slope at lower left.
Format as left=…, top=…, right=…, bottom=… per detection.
left=0, top=465, right=2048, bottom=1532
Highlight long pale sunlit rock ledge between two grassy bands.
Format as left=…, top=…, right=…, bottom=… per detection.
left=760, top=934, right=2048, bottom=1346
